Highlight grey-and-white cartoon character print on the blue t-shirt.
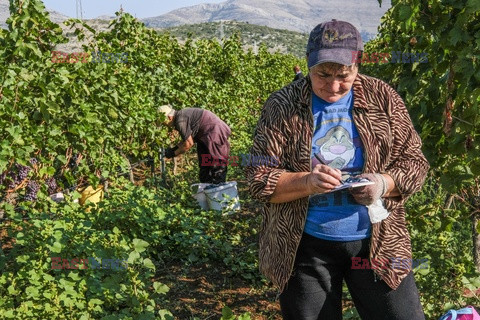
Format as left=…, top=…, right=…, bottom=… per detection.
left=312, top=126, right=355, bottom=170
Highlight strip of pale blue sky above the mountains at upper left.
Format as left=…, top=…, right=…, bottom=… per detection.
left=43, top=0, right=226, bottom=19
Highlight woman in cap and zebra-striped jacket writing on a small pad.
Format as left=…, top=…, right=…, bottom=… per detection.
left=246, top=21, right=429, bottom=320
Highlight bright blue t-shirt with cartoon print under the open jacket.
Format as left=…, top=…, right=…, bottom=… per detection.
left=304, top=90, right=371, bottom=241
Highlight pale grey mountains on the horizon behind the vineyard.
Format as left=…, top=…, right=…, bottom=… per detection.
left=0, top=0, right=390, bottom=40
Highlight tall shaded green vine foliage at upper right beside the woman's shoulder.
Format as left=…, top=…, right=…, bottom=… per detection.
left=364, top=0, right=480, bottom=192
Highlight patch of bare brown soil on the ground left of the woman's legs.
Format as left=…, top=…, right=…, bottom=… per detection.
left=160, top=265, right=281, bottom=320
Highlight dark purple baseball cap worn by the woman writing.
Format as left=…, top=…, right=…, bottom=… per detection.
left=307, top=19, right=363, bottom=68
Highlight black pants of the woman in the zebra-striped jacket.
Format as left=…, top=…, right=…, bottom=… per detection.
left=280, top=234, right=425, bottom=320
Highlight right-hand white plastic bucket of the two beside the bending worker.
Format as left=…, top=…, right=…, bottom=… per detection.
left=203, top=181, right=240, bottom=211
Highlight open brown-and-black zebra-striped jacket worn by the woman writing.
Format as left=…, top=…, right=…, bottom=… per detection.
left=245, top=74, right=429, bottom=291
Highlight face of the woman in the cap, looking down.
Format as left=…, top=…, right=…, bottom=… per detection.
left=309, top=63, right=358, bottom=103
